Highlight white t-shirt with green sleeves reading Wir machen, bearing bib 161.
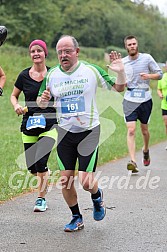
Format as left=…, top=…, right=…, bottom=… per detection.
left=39, top=62, right=115, bottom=133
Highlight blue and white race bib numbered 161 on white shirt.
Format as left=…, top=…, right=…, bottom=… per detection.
left=61, top=96, right=85, bottom=116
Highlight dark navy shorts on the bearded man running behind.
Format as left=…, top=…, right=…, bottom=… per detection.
left=123, top=99, right=153, bottom=124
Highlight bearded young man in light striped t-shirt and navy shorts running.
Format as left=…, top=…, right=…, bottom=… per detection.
left=123, top=35, right=162, bottom=173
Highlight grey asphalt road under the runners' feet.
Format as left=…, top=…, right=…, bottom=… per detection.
left=0, top=142, right=167, bottom=252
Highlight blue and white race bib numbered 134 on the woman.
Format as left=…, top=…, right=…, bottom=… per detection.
left=26, top=115, right=46, bottom=130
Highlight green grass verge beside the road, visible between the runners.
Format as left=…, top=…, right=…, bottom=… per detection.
left=0, top=45, right=166, bottom=201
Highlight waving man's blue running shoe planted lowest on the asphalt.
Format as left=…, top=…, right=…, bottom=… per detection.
left=64, top=214, right=84, bottom=232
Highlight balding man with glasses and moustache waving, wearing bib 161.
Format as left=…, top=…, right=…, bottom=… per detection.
left=37, top=35, right=125, bottom=232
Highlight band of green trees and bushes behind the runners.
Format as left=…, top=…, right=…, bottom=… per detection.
left=0, top=0, right=167, bottom=62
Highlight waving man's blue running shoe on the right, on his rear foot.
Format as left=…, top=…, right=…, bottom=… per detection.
left=92, top=189, right=106, bottom=221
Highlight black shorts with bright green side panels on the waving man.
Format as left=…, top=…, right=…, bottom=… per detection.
left=57, top=126, right=100, bottom=172
